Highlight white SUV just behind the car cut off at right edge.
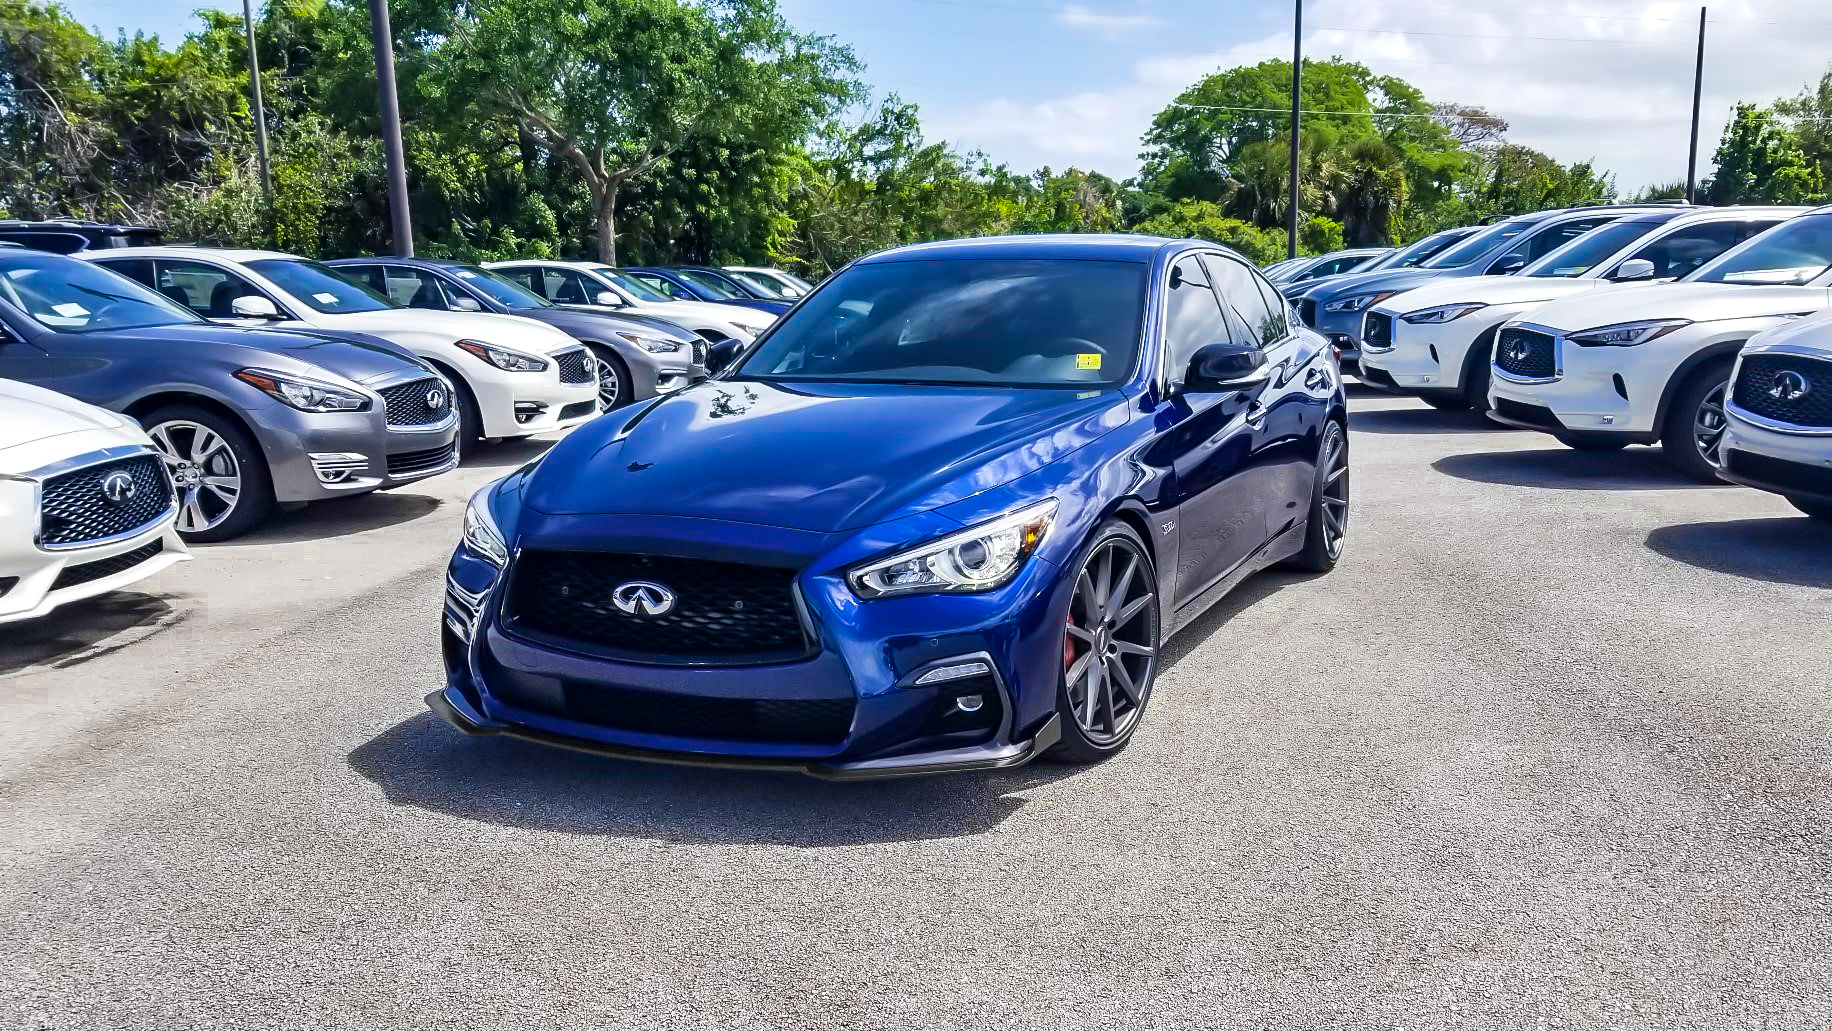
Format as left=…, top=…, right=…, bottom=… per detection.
left=1489, top=207, right=1832, bottom=482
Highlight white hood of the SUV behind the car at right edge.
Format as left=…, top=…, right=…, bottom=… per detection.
left=1530, top=282, right=1827, bottom=331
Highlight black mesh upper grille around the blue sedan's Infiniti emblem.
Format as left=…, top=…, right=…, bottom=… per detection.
left=504, top=549, right=808, bottom=663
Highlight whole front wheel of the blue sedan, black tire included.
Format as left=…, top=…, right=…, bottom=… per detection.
left=1044, top=520, right=1161, bottom=764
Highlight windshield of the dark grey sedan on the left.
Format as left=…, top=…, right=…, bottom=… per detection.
left=0, top=247, right=203, bottom=333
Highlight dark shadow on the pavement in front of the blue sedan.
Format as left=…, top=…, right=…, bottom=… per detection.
left=348, top=712, right=1085, bottom=848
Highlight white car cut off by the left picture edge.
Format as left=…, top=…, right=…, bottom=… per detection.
left=0, top=379, right=191, bottom=623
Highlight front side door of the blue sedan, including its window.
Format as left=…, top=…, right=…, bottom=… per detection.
left=1145, top=255, right=1266, bottom=606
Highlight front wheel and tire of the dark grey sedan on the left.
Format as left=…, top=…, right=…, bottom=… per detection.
left=139, top=405, right=273, bottom=544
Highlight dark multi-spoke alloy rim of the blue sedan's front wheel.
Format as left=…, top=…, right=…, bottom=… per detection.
left=1063, top=537, right=1158, bottom=745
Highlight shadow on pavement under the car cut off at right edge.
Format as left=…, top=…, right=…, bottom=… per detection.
left=1647, top=516, right=1832, bottom=588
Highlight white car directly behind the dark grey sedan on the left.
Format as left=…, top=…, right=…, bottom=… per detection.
left=79, top=247, right=599, bottom=449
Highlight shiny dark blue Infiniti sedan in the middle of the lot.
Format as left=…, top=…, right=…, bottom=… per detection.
left=427, top=236, right=1348, bottom=780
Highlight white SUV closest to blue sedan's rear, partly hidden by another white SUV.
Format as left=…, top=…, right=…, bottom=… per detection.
left=1361, top=207, right=1806, bottom=410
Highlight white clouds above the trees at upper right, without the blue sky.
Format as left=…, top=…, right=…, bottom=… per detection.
left=925, top=0, right=1832, bottom=190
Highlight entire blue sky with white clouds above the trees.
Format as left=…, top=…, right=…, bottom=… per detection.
left=50, top=0, right=1832, bottom=189
